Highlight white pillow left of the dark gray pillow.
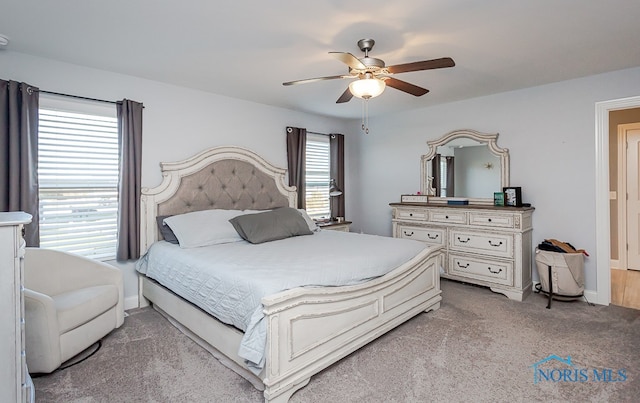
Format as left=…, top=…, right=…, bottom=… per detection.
left=164, top=210, right=251, bottom=248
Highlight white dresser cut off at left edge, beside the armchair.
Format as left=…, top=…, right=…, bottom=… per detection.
left=0, top=212, right=35, bottom=402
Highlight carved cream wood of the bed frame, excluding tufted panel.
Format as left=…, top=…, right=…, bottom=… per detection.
left=139, top=147, right=442, bottom=402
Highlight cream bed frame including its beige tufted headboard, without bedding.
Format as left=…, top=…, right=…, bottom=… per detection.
left=139, top=147, right=442, bottom=402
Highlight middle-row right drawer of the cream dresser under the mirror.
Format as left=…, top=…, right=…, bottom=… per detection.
left=449, top=229, right=513, bottom=258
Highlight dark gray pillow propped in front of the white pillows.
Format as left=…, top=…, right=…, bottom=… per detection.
left=229, top=207, right=313, bottom=244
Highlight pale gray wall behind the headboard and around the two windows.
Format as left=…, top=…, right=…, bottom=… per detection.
left=0, top=51, right=357, bottom=307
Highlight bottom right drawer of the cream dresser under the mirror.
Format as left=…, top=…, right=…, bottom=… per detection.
left=449, top=253, right=513, bottom=286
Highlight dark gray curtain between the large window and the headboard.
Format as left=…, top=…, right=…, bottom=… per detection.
left=116, top=99, right=144, bottom=260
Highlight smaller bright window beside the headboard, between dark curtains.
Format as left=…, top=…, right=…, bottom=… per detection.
left=305, top=133, right=331, bottom=219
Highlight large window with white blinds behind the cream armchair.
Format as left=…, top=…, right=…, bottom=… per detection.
left=38, top=97, right=119, bottom=260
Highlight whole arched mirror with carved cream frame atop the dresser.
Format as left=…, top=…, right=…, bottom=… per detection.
left=420, top=130, right=509, bottom=204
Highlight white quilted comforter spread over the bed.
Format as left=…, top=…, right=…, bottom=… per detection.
left=136, top=230, right=426, bottom=373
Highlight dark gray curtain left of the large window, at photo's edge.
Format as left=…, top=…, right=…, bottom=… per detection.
left=0, top=80, right=40, bottom=246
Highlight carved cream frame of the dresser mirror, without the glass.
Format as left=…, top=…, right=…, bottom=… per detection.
left=420, top=129, right=509, bottom=204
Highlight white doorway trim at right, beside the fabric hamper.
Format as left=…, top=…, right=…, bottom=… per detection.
left=592, top=96, right=640, bottom=305
